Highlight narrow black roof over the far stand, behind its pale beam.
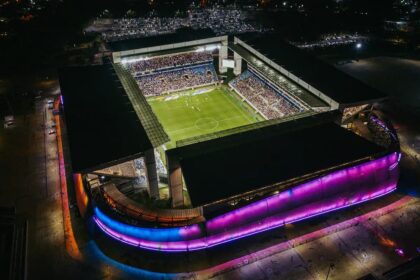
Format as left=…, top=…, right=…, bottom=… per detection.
left=108, top=28, right=216, bottom=52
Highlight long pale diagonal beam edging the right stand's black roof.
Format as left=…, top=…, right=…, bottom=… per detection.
left=234, top=37, right=339, bottom=109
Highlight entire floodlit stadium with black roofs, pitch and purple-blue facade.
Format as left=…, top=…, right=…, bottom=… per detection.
left=59, top=32, right=400, bottom=252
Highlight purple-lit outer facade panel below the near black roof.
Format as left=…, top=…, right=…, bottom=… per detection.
left=203, top=153, right=398, bottom=237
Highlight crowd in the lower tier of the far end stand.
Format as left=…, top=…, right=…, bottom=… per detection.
left=136, top=63, right=218, bottom=96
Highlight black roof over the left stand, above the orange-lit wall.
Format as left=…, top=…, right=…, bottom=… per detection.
left=59, top=64, right=152, bottom=172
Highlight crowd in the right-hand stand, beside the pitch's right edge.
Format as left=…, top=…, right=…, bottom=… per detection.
left=229, top=70, right=303, bottom=119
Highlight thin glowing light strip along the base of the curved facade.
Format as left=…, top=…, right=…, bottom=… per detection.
left=93, top=187, right=396, bottom=252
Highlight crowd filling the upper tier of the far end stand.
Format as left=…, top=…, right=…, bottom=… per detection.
left=125, top=51, right=213, bottom=75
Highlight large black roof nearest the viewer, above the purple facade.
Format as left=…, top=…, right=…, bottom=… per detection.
left=167, top=113, right=385, bottom=206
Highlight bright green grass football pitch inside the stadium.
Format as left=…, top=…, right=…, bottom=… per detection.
left=148, top=86, right=263, bottom=148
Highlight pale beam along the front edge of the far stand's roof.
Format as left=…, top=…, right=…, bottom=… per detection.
left=112, top=36, right=228, bottom=63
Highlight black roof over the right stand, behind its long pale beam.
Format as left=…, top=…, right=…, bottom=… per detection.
left=236, top=33, right=386, bottom=105
